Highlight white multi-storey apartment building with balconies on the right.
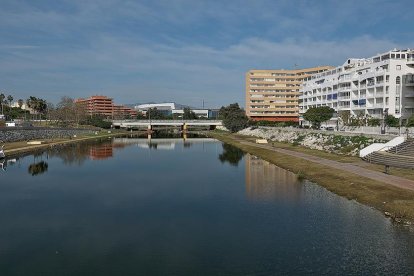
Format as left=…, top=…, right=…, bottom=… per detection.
left=299, top=49, right=414, bottom=125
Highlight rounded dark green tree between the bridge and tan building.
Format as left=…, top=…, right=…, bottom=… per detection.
left=219, top=103, right=249, bottom=132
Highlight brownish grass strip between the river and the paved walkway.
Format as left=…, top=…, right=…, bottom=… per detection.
left=209, top=132, right=414, bottom=224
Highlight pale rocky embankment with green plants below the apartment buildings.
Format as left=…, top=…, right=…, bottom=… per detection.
left=238, top=127, right=395, bottom=156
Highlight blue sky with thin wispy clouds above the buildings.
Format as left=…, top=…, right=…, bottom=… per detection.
left=0, top=0, right=414, bottom=108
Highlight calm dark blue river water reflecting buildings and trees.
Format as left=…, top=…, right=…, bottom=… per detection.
left=0, top=138, right=414, bottom=275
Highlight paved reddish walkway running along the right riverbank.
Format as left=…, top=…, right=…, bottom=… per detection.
left=237, top=139, right=414, bottom=191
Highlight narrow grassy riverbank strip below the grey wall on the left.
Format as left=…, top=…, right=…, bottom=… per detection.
left=4, top=130, right=129, bottom=157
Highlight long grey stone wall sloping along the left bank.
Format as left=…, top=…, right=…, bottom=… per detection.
left=0, top=128, right=95, bottom=142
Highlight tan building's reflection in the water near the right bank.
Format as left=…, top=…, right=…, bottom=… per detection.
left=245, top=154, right=303, bottom=200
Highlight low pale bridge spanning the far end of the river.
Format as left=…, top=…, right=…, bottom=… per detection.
left=112, top=120, right=222, bottom=130
